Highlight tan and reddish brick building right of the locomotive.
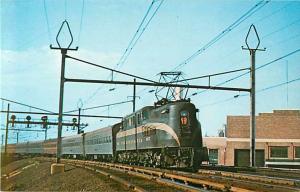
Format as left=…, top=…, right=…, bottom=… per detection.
left=204, top=110, right=300, bottom=167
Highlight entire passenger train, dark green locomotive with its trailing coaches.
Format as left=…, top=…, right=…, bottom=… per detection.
left=4, top=100, right=208, bottom=167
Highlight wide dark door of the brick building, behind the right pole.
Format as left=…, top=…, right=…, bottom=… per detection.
left=234, top=149, right=265, bottom=167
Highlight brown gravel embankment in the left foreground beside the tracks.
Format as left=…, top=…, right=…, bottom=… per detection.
left=1, top=160, right=129, bottom=192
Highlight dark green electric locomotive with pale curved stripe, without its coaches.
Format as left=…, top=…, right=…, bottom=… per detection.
left=115, top=100, right=207, bottom=167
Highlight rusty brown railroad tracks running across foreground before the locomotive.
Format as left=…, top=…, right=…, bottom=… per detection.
left=37, top=159, right=300, bottom=192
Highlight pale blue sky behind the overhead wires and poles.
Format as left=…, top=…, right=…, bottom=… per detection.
left=1, top=0, right=300, bottom=143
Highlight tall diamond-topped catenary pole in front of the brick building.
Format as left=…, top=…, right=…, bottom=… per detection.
left=242, top=24, right=266, bottom=167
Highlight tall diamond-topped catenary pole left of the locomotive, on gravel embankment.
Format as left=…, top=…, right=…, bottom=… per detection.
left=50, top=20, right=78, bottom=163
